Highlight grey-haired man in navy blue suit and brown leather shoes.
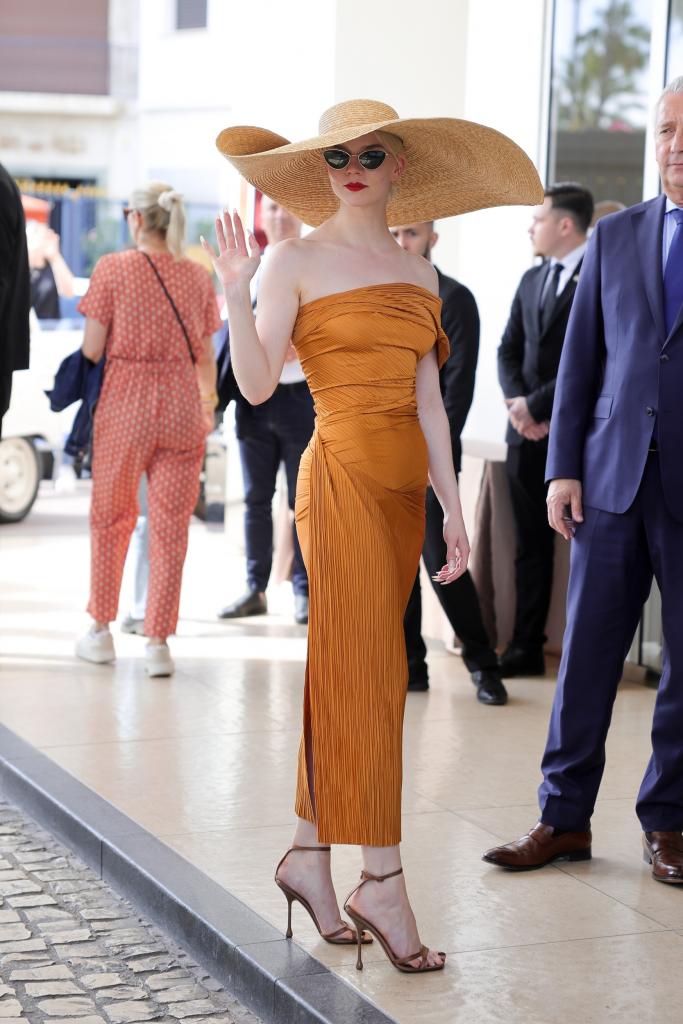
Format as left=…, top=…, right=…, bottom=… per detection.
left=484, top=77, right=683, bottom=884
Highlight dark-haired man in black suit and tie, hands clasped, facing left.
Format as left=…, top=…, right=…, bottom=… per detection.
left=498, top=182, right=593, bottom=677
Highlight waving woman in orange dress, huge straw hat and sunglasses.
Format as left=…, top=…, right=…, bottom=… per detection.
left=204, top=100, right=543, bottom=973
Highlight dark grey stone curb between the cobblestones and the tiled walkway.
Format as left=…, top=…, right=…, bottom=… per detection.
left=0, top=725, right=396, bottom=1024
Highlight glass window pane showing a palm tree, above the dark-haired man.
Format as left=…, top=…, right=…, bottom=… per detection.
left=548, top=0, right=655, bottom=206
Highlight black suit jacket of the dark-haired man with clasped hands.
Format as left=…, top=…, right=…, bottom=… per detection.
left=498, top=263, right=581, bottom=445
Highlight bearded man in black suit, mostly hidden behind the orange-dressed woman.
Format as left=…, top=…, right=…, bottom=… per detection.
left=391, top=221, right=508, bottom=705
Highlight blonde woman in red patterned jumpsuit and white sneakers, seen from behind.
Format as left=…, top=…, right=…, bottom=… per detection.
left=76, top=182, right=220, bottom=676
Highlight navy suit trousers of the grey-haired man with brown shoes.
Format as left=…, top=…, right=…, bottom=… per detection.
left=539, top=453, right=683, bottom=831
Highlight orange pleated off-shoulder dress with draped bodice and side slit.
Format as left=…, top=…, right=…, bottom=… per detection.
left=293, top=284, right=449, bottom=846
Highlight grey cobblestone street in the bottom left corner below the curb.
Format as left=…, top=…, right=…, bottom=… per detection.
left=0, top=795, right=259, bottom=1024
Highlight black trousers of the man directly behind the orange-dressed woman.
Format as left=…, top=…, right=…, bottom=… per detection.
left=403, top=487, right=498, bottom=682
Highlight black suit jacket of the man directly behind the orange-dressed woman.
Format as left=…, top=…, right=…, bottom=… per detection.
left=435, top=267, right=479, bottom=473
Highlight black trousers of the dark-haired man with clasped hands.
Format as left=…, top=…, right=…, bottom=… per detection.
left=506, top=440, right=555, bottom=651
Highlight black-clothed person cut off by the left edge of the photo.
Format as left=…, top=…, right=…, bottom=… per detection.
left=0, top=164, right=31, bottom=431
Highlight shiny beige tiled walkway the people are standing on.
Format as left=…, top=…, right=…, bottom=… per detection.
left=0, top=485, right=683, bottom=1024
